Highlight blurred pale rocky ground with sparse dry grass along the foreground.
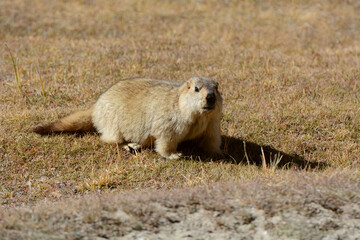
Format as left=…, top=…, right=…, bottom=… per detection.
left=0, top=173, right=360, bottom=239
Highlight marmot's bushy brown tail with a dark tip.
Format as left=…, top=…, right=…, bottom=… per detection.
left=33, top=106, right=95, bottom=135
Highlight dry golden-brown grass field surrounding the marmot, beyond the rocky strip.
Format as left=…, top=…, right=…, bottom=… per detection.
left=0, top=0, right=360, bottom=206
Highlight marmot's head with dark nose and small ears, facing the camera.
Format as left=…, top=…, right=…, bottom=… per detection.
left=180, top=77, right=222, bottom=113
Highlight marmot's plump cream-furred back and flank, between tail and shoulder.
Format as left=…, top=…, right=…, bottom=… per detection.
left=93, top=79, right=183, bottom=143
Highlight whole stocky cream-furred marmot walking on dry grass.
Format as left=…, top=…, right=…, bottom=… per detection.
left=33, top=77, right=222, bottom=159
